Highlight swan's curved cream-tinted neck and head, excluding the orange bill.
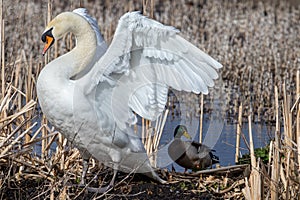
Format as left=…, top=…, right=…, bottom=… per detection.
left=47, top=12, right=97, bottom=80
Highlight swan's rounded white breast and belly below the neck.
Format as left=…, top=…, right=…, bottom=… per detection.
left=37, top=63, right=112, bottom=149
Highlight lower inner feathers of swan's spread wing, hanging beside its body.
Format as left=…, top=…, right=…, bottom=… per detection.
left=111, top=76, right=168, bottom=129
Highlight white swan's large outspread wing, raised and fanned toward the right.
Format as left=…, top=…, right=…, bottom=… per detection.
left=86, top=12, right=222, bottom=128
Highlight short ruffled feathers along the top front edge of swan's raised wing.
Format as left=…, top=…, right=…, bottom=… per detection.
left=88, top=12, right=178, bottom=87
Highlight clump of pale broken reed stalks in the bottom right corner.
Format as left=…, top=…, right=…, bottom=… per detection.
left=243, top=72, right=300, bottom=199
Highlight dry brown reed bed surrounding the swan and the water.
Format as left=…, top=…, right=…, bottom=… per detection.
left=0, top=0, right=300, bottom=199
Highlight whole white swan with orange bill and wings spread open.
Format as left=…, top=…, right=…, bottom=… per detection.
left=37, top=8, right=222, bottom=189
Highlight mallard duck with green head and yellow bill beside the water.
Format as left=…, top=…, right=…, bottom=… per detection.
left=168, top=125, right=219, bottom=172
